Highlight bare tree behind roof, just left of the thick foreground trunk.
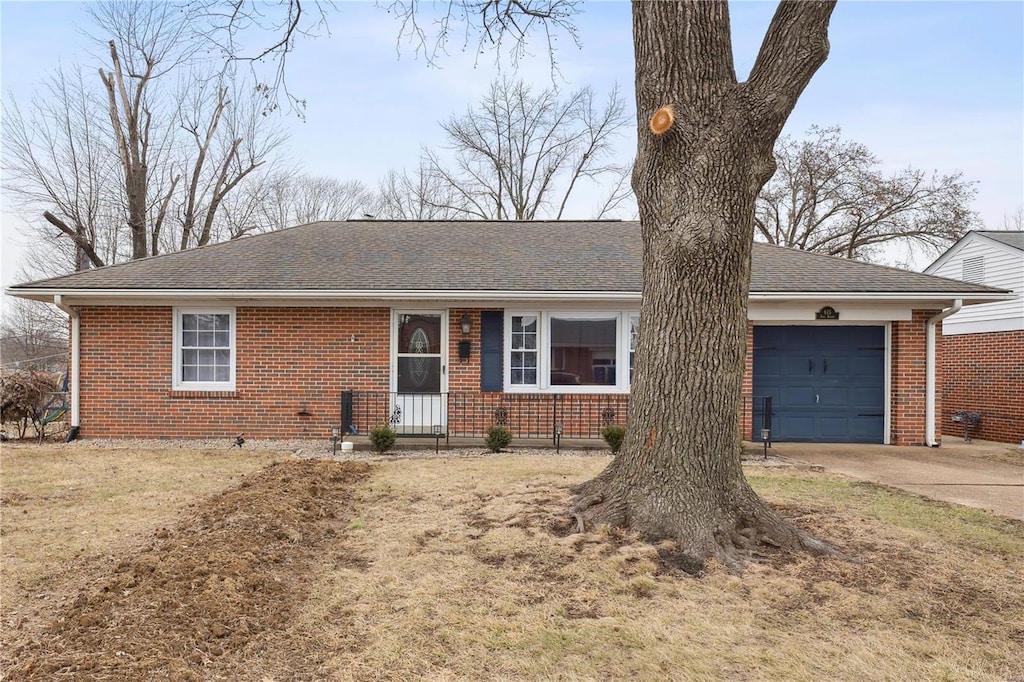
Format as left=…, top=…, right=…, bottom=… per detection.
left=417, top=80, right=630, bottom=220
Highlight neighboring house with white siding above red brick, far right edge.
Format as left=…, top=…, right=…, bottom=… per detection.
left=925, top=230, right=1024, bottom=443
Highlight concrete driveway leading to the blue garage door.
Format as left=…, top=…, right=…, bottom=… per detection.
left=772, top=436, right=1024, bottom=521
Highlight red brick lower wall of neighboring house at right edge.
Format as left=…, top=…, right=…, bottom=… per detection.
left=938, top=331, right=1024, bottom=443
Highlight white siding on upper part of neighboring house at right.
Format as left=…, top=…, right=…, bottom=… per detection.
left=929, top=238, right=1024, bottom=335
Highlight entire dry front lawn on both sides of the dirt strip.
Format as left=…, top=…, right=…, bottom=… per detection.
left=2, top=449, right=1024, bottom=680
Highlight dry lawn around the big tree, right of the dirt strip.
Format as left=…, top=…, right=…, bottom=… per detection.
left=305, top=458, right=1024, bottom=680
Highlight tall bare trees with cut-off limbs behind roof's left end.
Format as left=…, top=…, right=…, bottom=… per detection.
left=4, top=0, right=283, bottom=273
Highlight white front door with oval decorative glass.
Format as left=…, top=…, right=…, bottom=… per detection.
left=390, top=311, right=447, bottom=435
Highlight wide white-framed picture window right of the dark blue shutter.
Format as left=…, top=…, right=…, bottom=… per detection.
left=505, top=310, right=639, bottom=393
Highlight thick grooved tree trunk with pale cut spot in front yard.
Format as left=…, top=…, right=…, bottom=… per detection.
left=575, top=1, right=835, bottom=568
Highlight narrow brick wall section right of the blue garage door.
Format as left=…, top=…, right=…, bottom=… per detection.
left=889, top=310, right=942, bottom=445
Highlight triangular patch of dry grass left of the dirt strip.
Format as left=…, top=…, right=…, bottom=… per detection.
left=0, top=443, right=281, bottom=642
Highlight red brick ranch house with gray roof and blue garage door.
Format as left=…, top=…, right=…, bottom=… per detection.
left=7, top=221, right=1009, bottom=444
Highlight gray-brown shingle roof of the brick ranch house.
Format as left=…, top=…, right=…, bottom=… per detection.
left=11, top=220, right=996, bottom=294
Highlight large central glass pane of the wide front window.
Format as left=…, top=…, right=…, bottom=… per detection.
left=550, top=317, right=617, bottom=386
